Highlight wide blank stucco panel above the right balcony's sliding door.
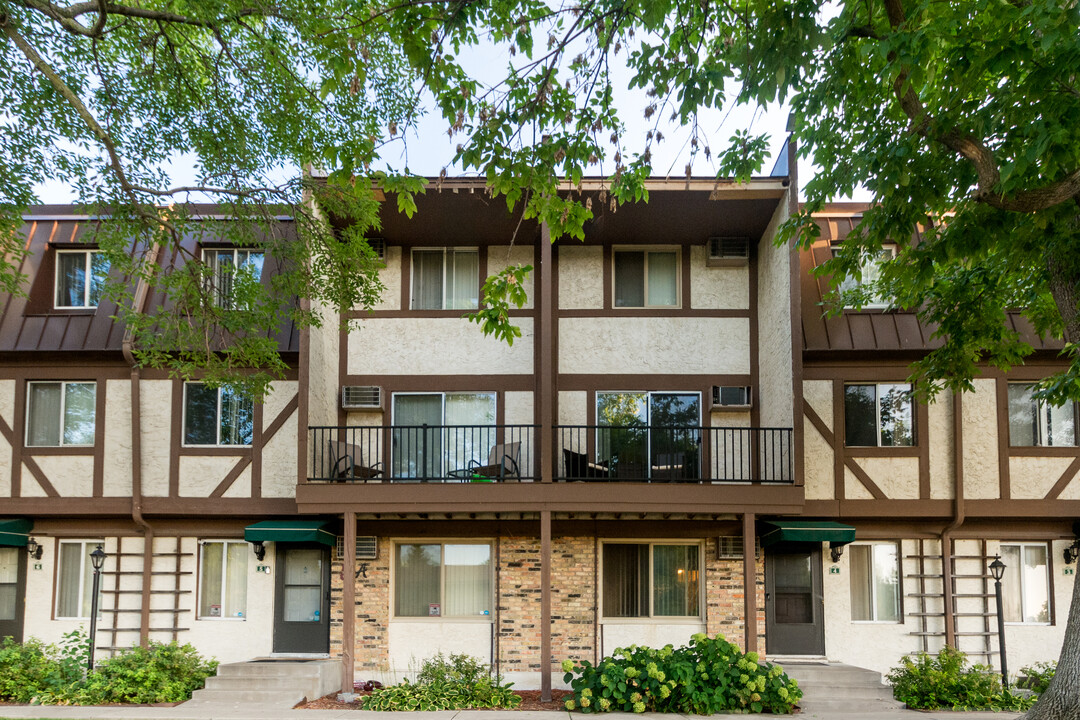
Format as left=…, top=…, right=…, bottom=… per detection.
left=557, top=317, right=751, bottom=377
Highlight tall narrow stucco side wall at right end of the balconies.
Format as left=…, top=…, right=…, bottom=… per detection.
left=755, top=195, right=798, bottom=427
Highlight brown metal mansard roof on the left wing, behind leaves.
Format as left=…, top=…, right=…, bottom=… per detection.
left=0, top=205, right=299, bottom=353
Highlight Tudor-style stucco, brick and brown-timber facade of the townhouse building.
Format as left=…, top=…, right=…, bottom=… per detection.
left=0, top=163, right=1080, bottom=688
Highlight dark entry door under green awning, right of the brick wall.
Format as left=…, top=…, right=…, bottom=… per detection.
left=765, top=545, right=825, bottom=655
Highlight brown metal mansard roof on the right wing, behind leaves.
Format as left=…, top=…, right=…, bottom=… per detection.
left=800, top=203, right=1062, bottom=355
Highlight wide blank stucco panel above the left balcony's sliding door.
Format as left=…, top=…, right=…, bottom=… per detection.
left=347, top=321, right=532, bottom=375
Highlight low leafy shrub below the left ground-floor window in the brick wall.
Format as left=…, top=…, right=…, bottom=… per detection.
left=362, top=653, right=522, bottom=711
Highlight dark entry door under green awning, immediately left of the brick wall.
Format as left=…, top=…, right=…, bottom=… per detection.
left=273, top=543, right=330, bottom=653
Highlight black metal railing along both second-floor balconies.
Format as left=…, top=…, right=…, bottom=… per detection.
left=309, top=425, right=794, bottom=484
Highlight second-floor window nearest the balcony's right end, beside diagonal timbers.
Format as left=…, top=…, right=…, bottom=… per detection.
left=843, top=383, right=915, bottom=448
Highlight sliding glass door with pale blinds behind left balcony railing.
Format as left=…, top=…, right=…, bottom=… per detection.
left=391, top=393, right=496, bottom=478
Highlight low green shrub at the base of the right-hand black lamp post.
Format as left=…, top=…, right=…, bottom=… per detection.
left=887, top=647, right=1035, bottom=710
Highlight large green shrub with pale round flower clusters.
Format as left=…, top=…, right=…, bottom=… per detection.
left=563, top=633, right=802, bottom=715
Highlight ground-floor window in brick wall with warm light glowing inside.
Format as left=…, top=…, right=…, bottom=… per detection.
left=603, top=543, right=701, bottom=617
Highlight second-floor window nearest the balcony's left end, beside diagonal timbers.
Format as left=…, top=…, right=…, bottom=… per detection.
left=184, top=382, right=255, bottom=445
